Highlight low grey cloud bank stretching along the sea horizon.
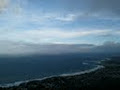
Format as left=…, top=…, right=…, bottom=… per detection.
left=0, top=41, right=120, bottom=56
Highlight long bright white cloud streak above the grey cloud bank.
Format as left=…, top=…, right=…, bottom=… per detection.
left=0, top=28, right=110, bottom=43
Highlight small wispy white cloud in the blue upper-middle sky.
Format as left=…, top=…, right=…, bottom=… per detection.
left=31, top=12, right=79, bottom=22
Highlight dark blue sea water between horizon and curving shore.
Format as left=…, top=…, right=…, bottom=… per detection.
left=0, top=54, right=106, bottom=84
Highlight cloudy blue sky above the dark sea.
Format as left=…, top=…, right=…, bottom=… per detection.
left=0, top=0, right=120, bottom=54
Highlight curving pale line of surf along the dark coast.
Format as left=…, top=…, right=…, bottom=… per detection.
left=0, top=65, right=104, bottom=88
